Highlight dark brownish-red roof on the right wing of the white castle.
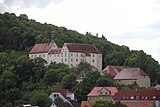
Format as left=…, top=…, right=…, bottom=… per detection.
left=65, top=43, right=101, bottom=56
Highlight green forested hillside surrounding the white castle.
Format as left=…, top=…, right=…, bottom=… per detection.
left=0, top=12, right=160, bottom=106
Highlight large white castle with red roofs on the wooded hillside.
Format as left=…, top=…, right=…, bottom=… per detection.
left=29, top=40, right=102, bottom=71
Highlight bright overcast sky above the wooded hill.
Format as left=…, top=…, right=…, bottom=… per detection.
left=0, top=0, right=160, bottom=62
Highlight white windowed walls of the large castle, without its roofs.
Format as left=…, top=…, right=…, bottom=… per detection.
left=29, top=43, right=102, bottom=72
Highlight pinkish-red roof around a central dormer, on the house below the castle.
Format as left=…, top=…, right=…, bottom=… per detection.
left=87, top=87, right=118, bottom=97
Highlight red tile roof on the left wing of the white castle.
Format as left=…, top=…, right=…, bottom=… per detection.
left=30, top=43, right=51, bottom=54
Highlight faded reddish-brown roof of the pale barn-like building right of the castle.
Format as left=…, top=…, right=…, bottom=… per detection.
left=114, top=68, right=147, bottom=80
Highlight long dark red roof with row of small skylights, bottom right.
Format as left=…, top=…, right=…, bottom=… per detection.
left=114, top=90, right=160, bottom=100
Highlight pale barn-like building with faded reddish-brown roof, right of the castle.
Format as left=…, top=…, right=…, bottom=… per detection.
left=114, top=68, right=151, bottom=88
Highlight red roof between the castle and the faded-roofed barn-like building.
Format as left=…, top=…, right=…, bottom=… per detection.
left=103, top=65, right=126, bottom=77
